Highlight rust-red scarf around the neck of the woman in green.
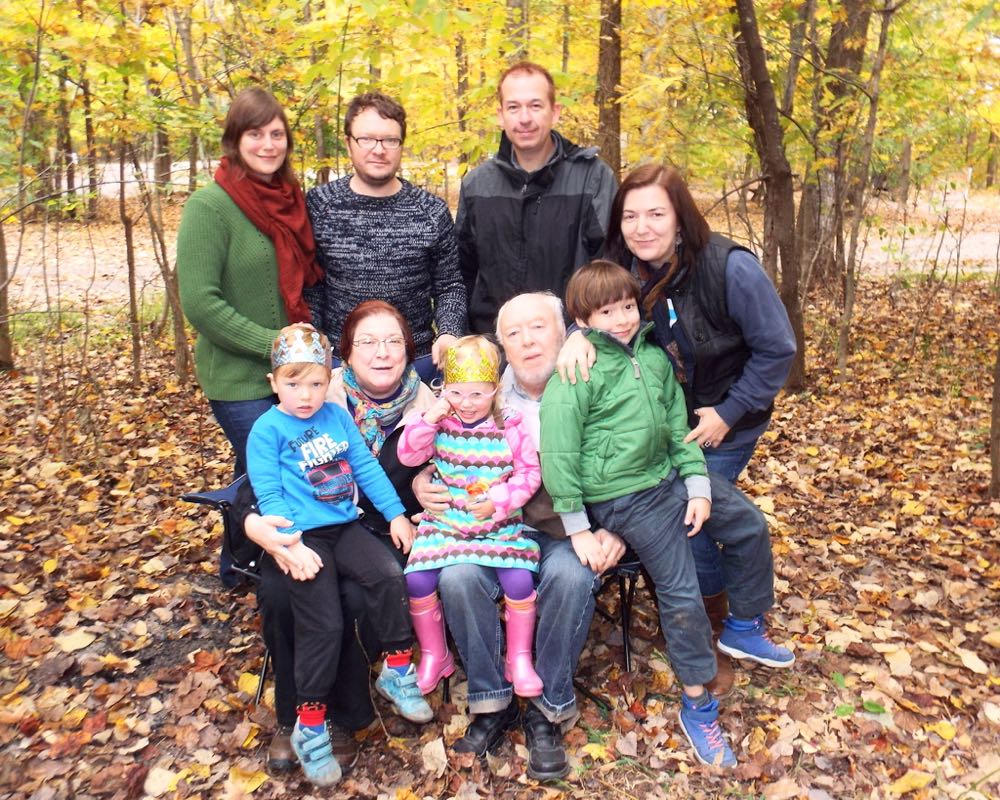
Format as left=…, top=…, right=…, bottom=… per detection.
left=215, top=156, right=323, bottom=323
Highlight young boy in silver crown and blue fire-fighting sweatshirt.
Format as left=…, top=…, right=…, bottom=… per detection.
left=247, top=325, right=433, bottom=786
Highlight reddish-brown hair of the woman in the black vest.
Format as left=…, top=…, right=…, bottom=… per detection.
left=604, top=164, right=712, bottom=278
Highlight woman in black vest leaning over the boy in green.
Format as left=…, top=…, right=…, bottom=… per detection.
left=559, top=164, right=795, bottom=696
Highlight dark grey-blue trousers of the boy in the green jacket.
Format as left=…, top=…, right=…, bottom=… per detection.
left=590, top=475, right=774, bottom=686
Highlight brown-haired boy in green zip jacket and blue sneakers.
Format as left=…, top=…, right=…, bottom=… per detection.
left=540, top=261, right=795, bottom=767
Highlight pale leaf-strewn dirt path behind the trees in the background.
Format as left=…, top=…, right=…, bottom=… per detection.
left=4, top=186, right=1000, bottom=315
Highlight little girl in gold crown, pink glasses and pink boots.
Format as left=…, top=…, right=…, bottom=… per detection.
left=398, top=336, right=542, bottom=697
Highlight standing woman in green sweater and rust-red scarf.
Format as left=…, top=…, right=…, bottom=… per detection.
left=177, top=88, right=321, bottom=484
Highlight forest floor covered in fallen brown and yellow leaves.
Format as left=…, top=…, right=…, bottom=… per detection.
left=0, top=194, right=1000, bottom=800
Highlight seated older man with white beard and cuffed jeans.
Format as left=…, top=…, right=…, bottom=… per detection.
left=414, top=293, right=625, bottom=780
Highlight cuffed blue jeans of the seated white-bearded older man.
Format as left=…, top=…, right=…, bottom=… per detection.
left=438, top=533, right=600, bottom=722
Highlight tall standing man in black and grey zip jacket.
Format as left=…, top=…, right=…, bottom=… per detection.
left=455, top=61, right=617, bottom=333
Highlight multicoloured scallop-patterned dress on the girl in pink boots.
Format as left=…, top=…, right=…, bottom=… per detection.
left=403, top=419, right=539, bottom=572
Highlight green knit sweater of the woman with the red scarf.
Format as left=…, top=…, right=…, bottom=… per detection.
left=177, top=183, right=288, bottom=400
